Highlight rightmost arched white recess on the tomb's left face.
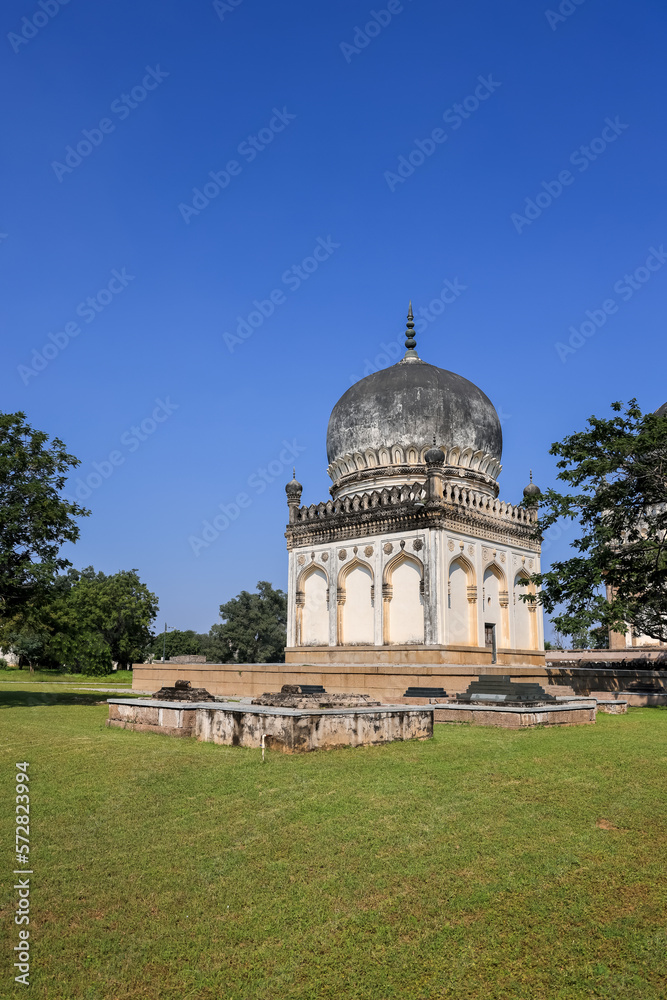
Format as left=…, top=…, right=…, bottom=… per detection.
left=382, top=552, right=424, bottom=645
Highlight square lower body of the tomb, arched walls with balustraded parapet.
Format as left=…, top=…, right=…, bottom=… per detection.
left=286, top=469, right=544, bottom=663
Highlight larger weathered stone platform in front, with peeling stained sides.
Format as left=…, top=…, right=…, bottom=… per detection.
left=107, top=698, right=433, bottom=753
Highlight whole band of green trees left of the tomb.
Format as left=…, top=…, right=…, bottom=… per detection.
left=0, top=412, right=287, bottom=674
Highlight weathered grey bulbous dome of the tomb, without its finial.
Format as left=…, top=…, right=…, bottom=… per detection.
left=327, top=357, right=503, bottom=466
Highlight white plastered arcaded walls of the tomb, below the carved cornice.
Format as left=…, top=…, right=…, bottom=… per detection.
left=287, top=528, right=544, bottom=650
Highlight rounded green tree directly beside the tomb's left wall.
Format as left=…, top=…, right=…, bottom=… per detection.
left=206, top=580, right=287, bottom=663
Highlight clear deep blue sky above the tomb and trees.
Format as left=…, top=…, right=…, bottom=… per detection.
left=0, top=0, right=667, bottom=630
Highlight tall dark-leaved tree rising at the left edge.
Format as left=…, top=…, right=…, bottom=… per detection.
left=0, top=412, right=90, bottom=644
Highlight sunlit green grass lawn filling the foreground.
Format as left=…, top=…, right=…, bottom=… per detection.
left=0, top=692, right=667, bottom=1000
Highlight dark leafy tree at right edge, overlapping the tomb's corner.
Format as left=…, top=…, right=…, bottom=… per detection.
left=523, top=399, right=667, bottom=648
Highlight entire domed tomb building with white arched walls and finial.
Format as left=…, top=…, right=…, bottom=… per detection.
left=286, top=307, right=544, bottom=666
